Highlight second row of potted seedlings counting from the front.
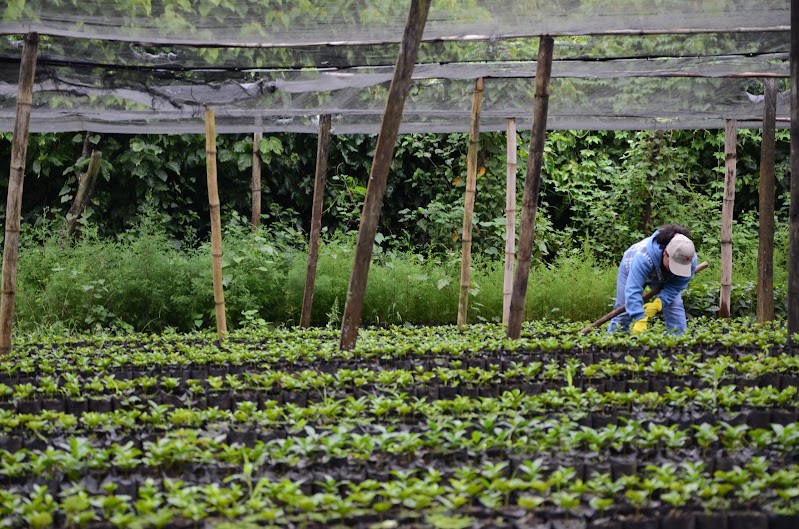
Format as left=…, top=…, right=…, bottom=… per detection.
left=0, top=421, right=799, bottom=484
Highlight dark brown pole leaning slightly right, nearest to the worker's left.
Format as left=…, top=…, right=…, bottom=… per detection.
left=508, top=35, right=554, bottom=339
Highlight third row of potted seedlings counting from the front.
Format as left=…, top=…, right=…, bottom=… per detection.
left=0, top=385, right=799, bottom=431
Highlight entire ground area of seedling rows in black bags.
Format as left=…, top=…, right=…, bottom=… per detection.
left=0, top=318, right=799, bottom=529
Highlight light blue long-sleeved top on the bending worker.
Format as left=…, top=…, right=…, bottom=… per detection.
left=622, top=231, right=697, bottom=321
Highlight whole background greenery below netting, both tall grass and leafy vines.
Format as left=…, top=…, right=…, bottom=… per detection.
left=0, top=125, right=788, bottom=330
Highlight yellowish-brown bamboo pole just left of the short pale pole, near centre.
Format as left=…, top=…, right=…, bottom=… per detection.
left=458, top=77, right=485, bottom=325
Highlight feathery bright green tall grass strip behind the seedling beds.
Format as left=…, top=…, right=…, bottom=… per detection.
left=16, top=217, right=784, bottom=331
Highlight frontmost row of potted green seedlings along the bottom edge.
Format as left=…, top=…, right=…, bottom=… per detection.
left=0, top=459, right=799, bottom=529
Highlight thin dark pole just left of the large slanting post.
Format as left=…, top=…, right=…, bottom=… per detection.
left=300, top=114, right=331, bottom=327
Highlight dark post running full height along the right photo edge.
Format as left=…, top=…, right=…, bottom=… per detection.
left=788, top=0, right=799, bottom=343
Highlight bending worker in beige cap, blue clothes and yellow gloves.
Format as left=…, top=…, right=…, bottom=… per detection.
left=608, top=224, right=697, bottom=334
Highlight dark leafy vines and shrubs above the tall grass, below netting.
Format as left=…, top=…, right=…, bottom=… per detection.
left=0, top=130, right=789, bottom=261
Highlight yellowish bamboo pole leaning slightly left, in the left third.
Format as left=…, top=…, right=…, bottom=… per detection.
left=205, top=110, right=227, bottom=341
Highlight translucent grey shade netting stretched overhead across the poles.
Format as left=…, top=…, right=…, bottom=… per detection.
left=0, top=0, right=790, bottom=134
